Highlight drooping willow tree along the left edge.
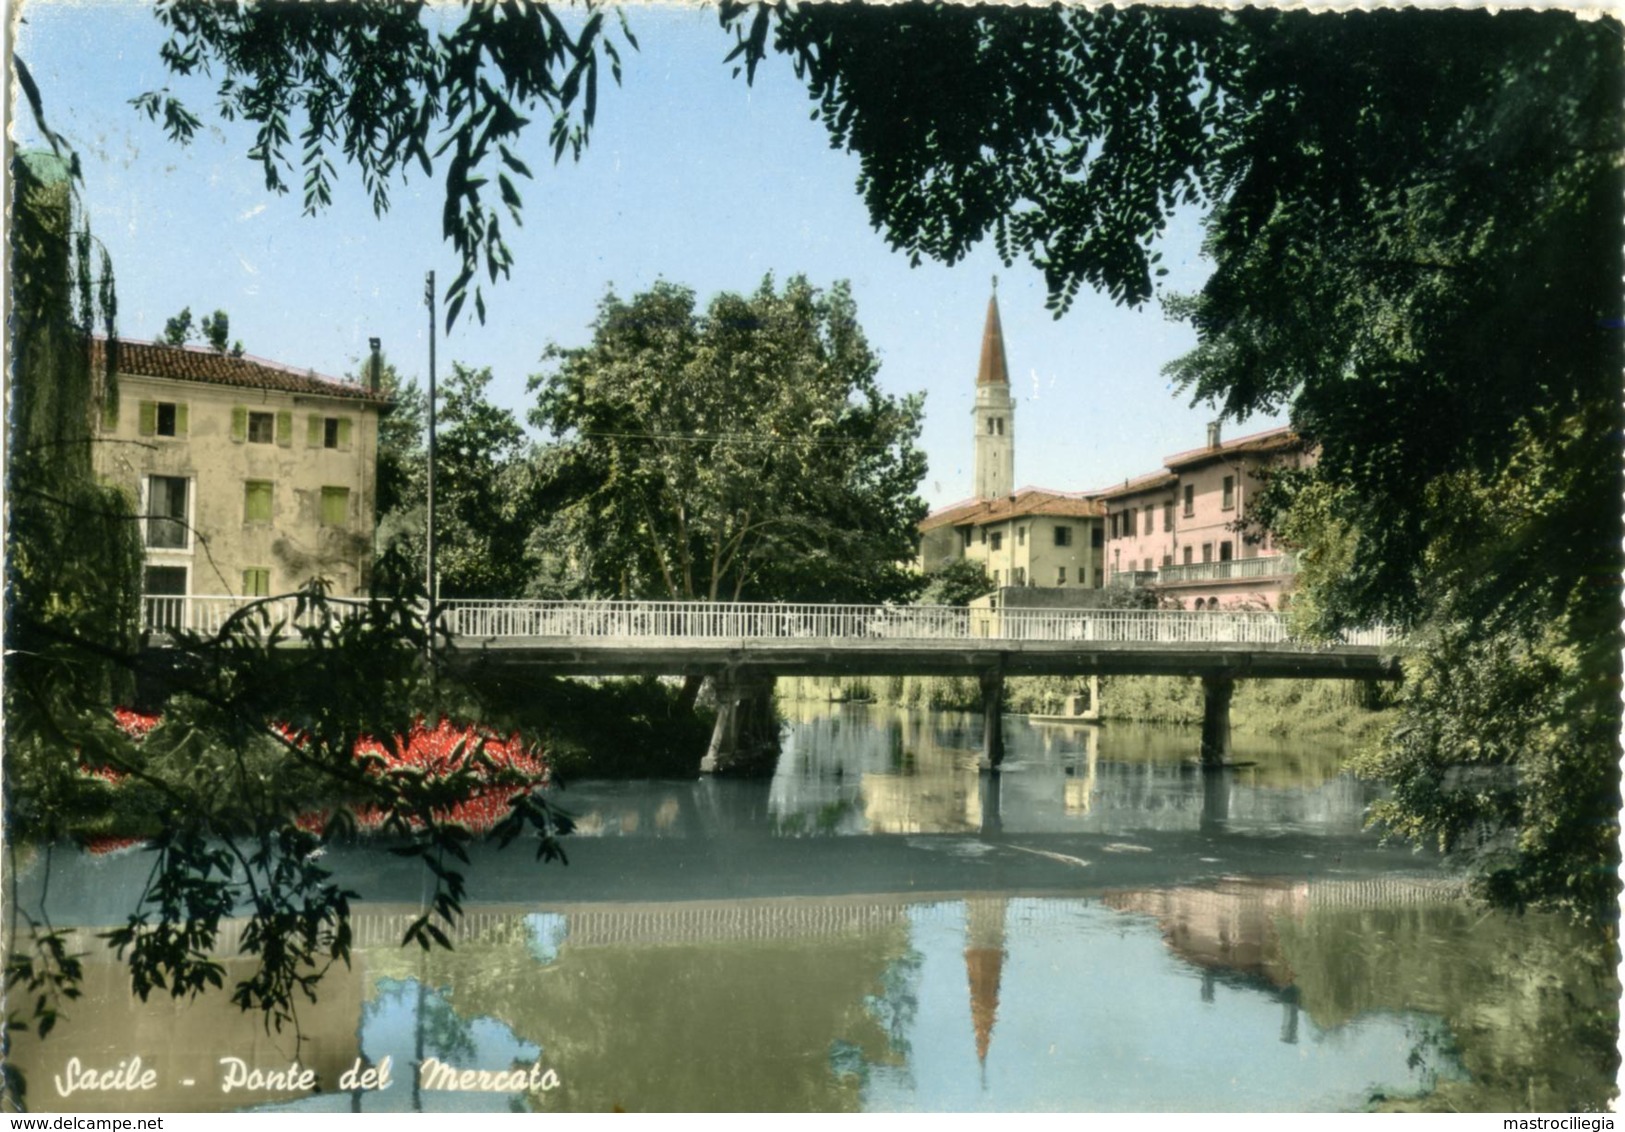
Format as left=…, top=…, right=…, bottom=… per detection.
left=0, top=153, right=141, bottom=1090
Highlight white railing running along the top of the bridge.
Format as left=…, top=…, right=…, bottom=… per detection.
left=141, top=596, right=1394, bottom=648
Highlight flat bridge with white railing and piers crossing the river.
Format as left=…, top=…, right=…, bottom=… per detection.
left=141, top=594, right=1399, bottom=765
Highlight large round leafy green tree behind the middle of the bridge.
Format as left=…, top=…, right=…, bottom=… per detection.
left=531, top=276, right=925, bottom=601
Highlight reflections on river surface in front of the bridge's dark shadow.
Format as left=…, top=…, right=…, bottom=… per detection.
left=18, top=880, right=1579, bottom=1111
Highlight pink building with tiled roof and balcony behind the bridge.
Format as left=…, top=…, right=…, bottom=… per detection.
left=1095, top=424, right=1313, bottom=609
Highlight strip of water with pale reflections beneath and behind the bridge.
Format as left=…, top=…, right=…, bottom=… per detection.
left=770, top=703, right=1370, bottom=835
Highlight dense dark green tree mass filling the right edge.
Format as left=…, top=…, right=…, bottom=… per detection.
left=1170, top=11, right=1625, bottom=914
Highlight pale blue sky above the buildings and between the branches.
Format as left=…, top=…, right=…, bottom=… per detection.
left=15, top=0, right=1277, bottom=507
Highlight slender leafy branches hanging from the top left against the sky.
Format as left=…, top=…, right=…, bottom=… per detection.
left=133, top=0, right=637, bottom=326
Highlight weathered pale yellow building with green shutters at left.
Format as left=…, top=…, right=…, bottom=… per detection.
left=93, top=341, right=388, bottom=596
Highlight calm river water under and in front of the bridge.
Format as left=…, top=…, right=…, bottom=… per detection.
left=15, top=705, right=1617, bottom=1111
